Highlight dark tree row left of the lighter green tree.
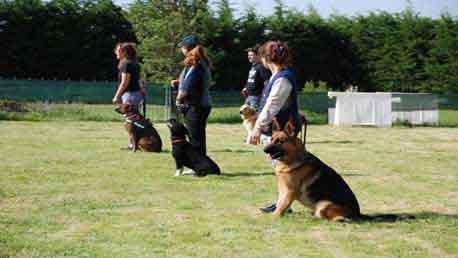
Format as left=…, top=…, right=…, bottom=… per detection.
left=0, top=0, right=136, bottom=80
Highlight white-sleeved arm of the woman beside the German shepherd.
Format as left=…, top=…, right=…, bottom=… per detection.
left=250, top=78, right=293, bottom=144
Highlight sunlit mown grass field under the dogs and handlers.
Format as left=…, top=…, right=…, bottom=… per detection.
left=0, top=121, right=458, bottom=258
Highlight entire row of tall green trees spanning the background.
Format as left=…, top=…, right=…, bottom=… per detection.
left=0, top=0, right=458, bottom=92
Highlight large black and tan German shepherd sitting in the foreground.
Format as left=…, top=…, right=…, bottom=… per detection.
left=264, top=123, right=364, bottom=221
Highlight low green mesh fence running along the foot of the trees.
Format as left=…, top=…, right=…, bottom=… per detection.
left=0, top=79, right=458, bottom=126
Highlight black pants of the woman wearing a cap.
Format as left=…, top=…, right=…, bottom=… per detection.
left=184, top=105, right=211, bottom=155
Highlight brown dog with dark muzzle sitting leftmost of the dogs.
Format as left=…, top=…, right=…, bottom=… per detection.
left=115, top=104, right=162, bottom=152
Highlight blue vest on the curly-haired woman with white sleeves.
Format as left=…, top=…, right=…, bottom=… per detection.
left=261, top=68, right=301, bottom=133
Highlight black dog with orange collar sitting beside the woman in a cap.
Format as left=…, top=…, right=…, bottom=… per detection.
left=167, top=119, right=221, bottom=176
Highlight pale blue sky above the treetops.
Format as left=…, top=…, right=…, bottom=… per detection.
left=114, top=0, right=458, bottom=18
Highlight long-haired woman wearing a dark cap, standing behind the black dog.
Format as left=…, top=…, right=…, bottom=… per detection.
left=172, top=35, right=211, bottom=155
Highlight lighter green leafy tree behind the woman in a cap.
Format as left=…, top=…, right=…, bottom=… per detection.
left=128, top=0, right=211, bottom=82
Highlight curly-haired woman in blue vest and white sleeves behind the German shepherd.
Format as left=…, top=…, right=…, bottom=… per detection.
left=249, top=41, right=300, bottom=212
